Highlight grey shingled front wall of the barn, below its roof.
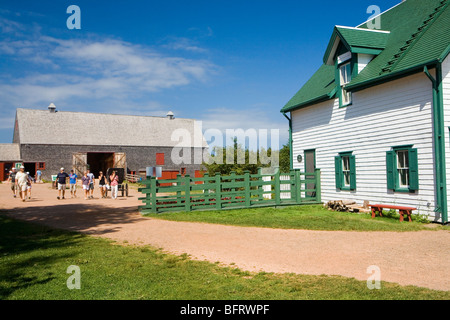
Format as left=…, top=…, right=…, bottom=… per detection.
left=21, top=145, right=206, bottom=180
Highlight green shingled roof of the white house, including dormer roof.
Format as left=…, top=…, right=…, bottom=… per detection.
left=281, top=0, right=450, bottom=112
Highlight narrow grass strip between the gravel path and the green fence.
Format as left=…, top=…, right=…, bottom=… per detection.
left=142, top=205, right=450, bottom=231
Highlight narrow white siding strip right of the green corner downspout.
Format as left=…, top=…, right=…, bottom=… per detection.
left=442, top=56, right=450, bottom=222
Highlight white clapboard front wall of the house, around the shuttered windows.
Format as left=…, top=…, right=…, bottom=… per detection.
left=292, top=73, right=435, bottom=218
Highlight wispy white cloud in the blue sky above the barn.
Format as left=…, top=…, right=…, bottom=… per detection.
left=0, top=19, right=216, bottom=127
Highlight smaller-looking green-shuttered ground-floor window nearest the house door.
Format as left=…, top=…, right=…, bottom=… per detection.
left=334, top=152, right=356, bottom=190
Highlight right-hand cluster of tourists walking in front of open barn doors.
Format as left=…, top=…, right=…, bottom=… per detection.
left=56, top=168, right=119, bottom=200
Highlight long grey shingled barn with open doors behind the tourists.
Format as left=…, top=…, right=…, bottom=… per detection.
left=0, top=104, right=208, bottom=180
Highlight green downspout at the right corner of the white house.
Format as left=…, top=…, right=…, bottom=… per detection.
left=423, top=63, right=448, bottom=224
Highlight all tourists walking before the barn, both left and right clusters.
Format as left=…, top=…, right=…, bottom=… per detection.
left=7, top=166, right=119, bottom=201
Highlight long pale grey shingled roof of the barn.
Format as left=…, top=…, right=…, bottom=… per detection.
left=14, top=108, right=207, bottom=147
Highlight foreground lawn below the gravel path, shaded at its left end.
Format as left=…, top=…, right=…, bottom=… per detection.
left=0, top=215, right=450, bottom=300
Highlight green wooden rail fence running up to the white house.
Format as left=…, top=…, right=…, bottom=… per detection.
left=139, top=169, right=321, bottom=214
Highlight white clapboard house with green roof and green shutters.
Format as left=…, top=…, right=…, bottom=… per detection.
left=281, top=0, right=450, bottom=223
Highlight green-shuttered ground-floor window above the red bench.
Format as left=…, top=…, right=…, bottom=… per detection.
left=386, top=145, right=419, bottom=192
